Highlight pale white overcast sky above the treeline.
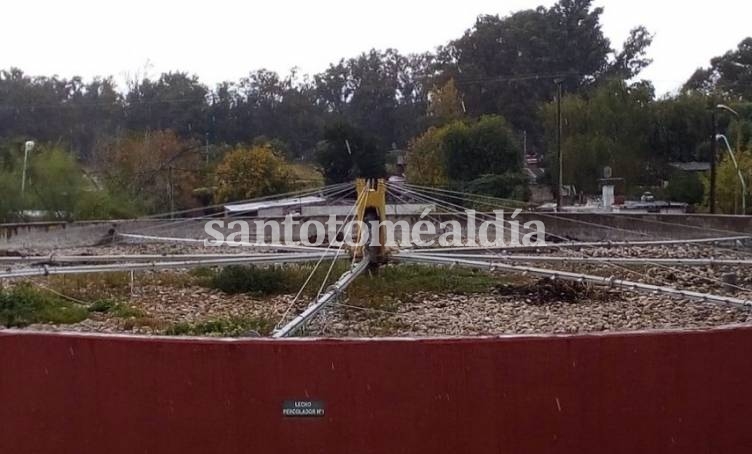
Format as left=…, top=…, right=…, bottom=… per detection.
left=0, top=0, right=752, bottom=94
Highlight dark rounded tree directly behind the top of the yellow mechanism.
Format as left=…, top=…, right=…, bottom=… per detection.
left=316, top=122, right=386, bottom=184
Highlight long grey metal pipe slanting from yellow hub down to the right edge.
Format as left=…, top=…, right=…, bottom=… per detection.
left=400, top=254, right=752, bottom=309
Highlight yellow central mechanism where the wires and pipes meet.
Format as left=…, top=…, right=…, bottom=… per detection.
left=354, top=178, right=387, bottom=264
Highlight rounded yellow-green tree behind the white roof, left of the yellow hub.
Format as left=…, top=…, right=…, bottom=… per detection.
left=214, top=145, right=292, bottom=203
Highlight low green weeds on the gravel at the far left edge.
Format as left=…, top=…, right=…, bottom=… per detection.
left=0, top=283, right=88, bottom=328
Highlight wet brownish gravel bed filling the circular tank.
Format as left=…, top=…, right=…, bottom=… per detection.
left=5, top=244, right=752, bottom=337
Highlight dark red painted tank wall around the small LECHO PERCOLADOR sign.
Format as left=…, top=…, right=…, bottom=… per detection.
left=0, top=328, right=752, bottom=454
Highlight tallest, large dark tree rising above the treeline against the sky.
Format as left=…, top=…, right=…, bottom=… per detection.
left=438, top=0, right=652, bottom=150
